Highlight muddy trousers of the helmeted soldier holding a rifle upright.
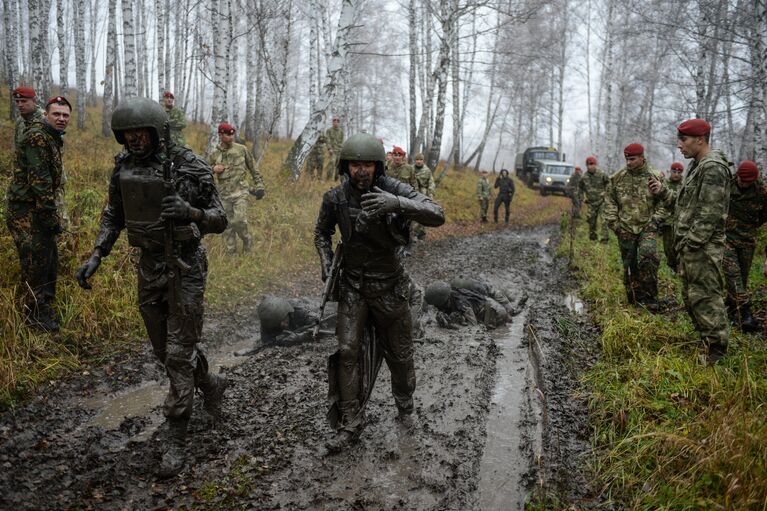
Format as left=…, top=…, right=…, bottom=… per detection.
left=138, top=246, right=208, bottom=419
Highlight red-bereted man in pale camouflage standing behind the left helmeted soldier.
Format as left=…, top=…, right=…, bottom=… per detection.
left=208, top=122, right=266, bottom=254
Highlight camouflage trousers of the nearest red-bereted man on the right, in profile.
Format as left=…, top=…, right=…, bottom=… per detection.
left=678, top=243, right=730, bottom=346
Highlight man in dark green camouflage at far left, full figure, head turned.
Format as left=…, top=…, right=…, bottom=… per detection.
left=6, top=96, right=72, bottom=332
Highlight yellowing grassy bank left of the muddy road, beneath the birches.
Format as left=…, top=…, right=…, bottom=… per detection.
left=0, top=91, right=566, bottom=409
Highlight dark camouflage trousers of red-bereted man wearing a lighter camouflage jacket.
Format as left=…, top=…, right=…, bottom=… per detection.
left=617, top=227, right=659, bottom=304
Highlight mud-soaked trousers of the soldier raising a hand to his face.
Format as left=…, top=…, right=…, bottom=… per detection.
left=336, top=273, right=415, bottom=428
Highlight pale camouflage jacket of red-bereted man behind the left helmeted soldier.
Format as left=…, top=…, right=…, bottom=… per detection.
left=208, top=142, right=264, bottom=200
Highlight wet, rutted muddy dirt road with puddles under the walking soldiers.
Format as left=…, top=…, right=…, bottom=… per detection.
left=0, top=226, right=594, bottom=510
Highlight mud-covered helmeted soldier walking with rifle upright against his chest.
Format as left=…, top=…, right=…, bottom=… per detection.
left=76, top=98, right=228, bottom=477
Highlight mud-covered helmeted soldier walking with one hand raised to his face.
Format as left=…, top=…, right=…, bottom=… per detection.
left=314, top=133, right=445, bottom=453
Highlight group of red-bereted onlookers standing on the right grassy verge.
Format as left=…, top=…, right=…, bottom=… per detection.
left=569, top=119, right=767, bottom=363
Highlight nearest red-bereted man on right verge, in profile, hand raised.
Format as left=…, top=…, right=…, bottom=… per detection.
left=650, top=119, right=731, bottom=364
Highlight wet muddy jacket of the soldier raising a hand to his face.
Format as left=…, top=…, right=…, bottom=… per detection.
left=314, top=176, right=445, bottom=279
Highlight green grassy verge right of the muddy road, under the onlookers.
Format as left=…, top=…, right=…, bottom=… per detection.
left=560, top=216, right=767, bottom=510
